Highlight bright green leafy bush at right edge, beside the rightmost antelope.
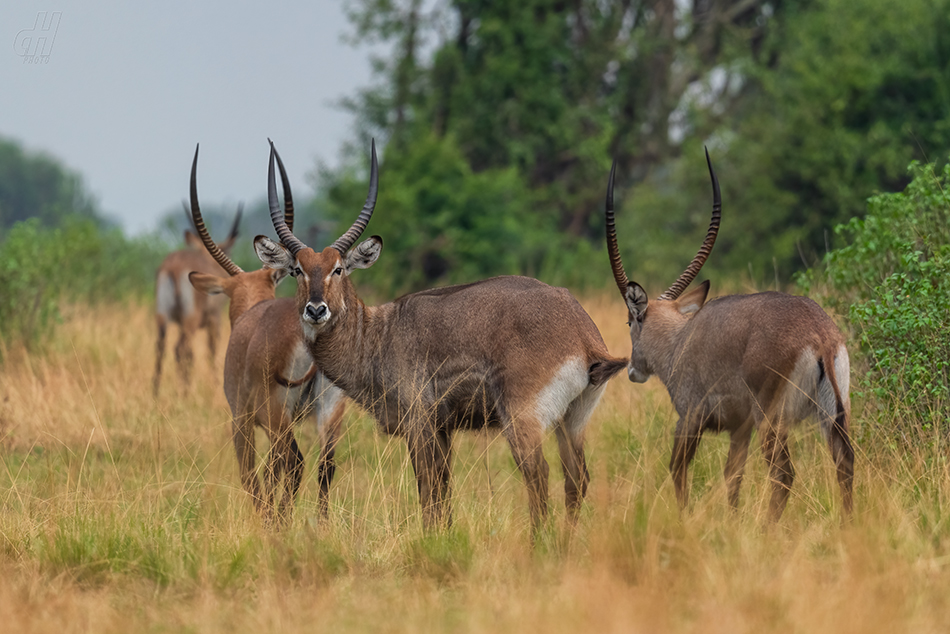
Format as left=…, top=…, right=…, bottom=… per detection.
left=802, top=163, right=950, bottom=428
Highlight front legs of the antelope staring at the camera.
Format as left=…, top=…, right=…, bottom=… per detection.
left=407, top=424, right=452, bottom=530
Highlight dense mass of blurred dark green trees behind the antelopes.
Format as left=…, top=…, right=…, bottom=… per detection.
left=318, top=0, right=950, bottom=288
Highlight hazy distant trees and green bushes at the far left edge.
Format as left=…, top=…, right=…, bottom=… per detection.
left=0, top=138, right=166, bottom=350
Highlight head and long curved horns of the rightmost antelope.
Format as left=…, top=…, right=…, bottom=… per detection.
left=606, top=151, right=722, bottom=383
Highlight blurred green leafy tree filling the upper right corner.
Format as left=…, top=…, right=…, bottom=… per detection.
left=717, top=0, right=950, bottom=272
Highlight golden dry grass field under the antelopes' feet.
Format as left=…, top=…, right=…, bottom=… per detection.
left=0, top=295, right=950, bottom=634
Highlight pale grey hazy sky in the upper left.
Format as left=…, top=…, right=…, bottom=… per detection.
left=0, top=0, right=384, bottom=233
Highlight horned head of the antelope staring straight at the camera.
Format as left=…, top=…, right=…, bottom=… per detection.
left=254, top=142, right=383, bottom=341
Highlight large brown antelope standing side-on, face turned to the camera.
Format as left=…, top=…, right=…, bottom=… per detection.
left=254, top=145, right=626, bottom=528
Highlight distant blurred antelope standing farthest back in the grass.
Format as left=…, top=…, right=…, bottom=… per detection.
left=152, top=198, right=242, bottom=396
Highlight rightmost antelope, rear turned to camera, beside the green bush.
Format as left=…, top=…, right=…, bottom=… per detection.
left=606, top=153, right=854, bottom=521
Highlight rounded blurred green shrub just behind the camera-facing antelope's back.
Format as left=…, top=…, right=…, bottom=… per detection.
left=322, top=136, right=547, bottom=293
